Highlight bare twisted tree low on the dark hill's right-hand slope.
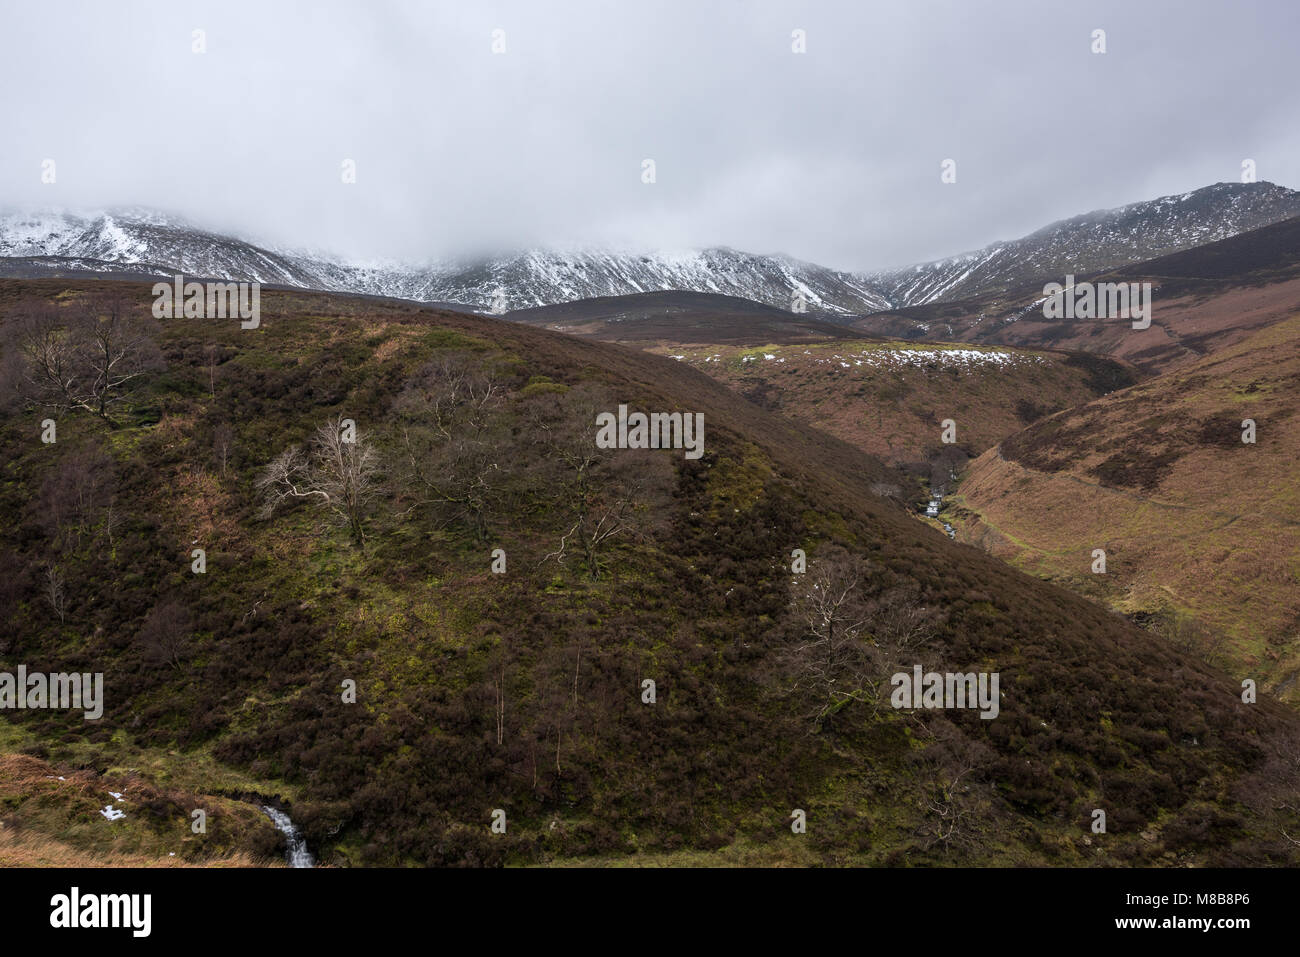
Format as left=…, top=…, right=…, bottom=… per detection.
left=784, top=545, right=940, bottom=729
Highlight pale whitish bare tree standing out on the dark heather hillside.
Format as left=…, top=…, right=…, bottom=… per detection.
left=257, top=416, right=378, bottom=547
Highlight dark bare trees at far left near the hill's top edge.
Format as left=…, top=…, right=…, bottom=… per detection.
left=7, top=293, right=163, bottom=425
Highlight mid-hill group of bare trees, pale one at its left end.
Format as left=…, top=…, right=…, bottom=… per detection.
left=256, top=352, right=675, bottom=579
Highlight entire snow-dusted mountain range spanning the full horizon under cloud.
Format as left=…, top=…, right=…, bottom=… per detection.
left=0, top=183, right=1300, bottom=316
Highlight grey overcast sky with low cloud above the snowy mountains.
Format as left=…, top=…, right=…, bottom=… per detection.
left=0, top=0, right=1300, bottom=269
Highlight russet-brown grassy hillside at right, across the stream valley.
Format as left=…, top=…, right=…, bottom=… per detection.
left=950, top=317, right=1300, bottom=701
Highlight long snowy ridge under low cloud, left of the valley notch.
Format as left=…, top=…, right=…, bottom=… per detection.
left=0, top=211, right=891, bottom=315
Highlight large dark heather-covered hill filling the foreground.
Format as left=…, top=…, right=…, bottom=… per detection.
left=0, top=281, right=1300, bottom=865
